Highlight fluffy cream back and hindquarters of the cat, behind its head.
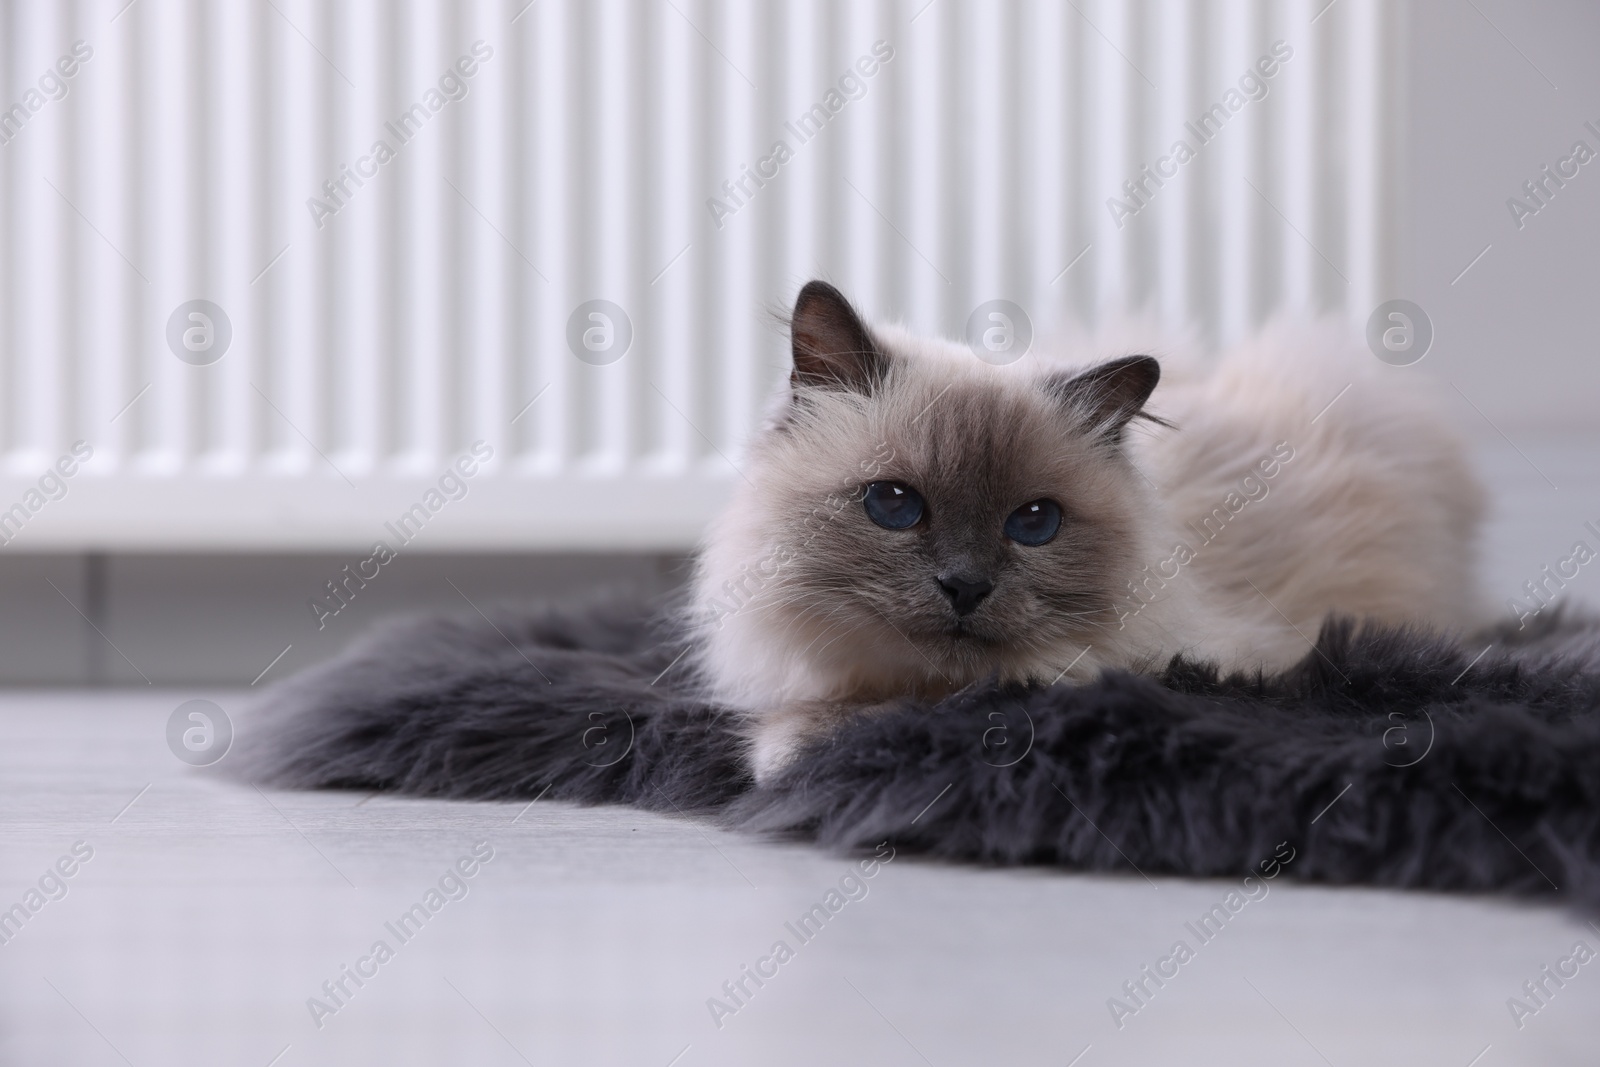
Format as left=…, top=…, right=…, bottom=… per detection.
left=1042, top=320, right=1488, bottom=669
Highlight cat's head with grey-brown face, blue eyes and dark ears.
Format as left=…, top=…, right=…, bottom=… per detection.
left=699, top=282, right=1160, bottom=697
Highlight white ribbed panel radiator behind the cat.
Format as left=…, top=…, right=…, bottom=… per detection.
left=0, top=0, right=1403, bottom=552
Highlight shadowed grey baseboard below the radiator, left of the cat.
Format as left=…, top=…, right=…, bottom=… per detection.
left=0, top=553, right=688, bottom=686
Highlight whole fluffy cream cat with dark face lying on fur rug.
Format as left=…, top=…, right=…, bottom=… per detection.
left=693, top=282, right=1483, bottom=779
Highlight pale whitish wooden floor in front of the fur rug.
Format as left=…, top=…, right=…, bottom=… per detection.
left=0, top=691, right=1600, bottom=1067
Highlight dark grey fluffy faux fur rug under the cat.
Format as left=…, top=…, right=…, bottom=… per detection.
left=234, top=600, right=1600, bottom=907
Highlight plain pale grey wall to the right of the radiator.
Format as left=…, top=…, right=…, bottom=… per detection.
left=1397, top=0, right=1600, bottom=443
